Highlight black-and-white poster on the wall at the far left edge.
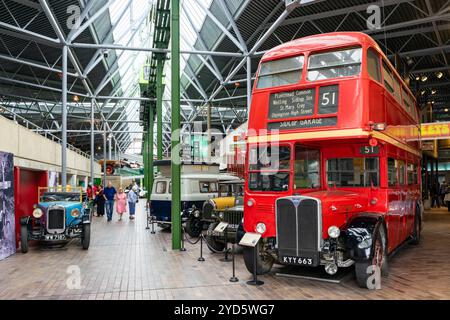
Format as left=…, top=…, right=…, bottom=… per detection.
left=0, top=151, right=16, bottom=260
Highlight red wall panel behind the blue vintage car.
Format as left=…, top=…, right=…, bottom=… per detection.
left=14, top=167, right=48, bottom=243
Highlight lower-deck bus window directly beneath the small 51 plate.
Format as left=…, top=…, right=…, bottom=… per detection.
left=327, top=158, right=380, bottom=187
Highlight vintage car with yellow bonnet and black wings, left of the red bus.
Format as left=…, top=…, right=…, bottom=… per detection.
left=202, top=180, right=244, bottom=251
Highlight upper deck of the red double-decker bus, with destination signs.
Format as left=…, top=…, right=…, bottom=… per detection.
left=248, top=32, right=419, bottom=153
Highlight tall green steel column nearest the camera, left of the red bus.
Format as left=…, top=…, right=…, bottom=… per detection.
left=170, top=0, right=181, bottom=250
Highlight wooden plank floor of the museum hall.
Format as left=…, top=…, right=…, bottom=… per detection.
left=0, top=201, right=450, bottom=300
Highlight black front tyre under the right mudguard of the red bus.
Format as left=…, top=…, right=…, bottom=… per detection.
left=355, top=226, right=389, bottom=289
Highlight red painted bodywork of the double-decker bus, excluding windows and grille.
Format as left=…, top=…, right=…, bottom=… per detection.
left=244, top=32, right=421, bottom=278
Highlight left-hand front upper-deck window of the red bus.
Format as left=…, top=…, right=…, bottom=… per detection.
left=256, top=56, right=304, bottom=89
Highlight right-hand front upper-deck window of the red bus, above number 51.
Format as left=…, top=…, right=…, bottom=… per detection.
left=308, top=48, right=362, bottom=81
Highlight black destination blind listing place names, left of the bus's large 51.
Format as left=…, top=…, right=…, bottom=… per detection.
left=269, top=89, right=316, bottom=119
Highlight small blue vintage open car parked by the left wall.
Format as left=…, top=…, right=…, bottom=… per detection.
left=20, top=188, right=91, bottom=253
